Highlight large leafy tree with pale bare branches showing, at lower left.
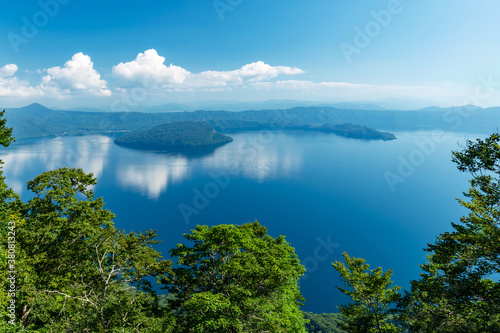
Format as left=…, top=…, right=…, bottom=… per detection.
left=8, top=168, right=171, bottom=332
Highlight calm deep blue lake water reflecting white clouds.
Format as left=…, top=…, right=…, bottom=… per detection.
left=0, top=131, right=484, bottom=313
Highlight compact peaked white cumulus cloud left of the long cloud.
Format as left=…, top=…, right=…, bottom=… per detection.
left=42, top=52, right=111, bottom=96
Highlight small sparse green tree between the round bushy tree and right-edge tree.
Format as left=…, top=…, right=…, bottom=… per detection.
left=332, top=252, right=402, bottom=333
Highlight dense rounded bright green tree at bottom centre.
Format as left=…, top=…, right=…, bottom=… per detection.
left=165, top=221, right=306, bottom=332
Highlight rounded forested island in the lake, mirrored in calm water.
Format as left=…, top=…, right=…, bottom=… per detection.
left=115, top=121, right=233, bottom=151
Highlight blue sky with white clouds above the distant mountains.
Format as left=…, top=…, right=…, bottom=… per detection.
left=0, top=0, right=500, bottom=111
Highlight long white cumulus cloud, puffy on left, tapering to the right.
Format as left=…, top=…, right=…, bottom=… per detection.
left=113, top=49, right=303, bottom=89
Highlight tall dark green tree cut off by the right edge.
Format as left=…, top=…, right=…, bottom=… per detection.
left=401, top=133, right=500, bottom=332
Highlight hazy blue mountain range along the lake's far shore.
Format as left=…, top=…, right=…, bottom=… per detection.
left=1, top=104, right=500, bottom=138
